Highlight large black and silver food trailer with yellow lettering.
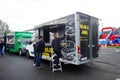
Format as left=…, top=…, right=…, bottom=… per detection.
left=27, top=12, right=99, bottom=65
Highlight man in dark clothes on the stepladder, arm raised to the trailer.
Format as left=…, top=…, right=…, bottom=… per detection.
left=52, top=33, right=65, bottom=67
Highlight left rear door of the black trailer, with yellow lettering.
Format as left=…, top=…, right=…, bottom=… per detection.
left=79, top=13, right=90, bottom=61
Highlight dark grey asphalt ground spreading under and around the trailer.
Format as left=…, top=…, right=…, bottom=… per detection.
left=0, top=49, right=120, bottom=80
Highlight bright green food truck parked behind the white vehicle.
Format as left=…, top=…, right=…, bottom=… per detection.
left=6, top=32, right=33, bottom=55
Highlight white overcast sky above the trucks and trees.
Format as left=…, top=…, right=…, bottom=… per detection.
left=0, top=0, right=120, bottom=31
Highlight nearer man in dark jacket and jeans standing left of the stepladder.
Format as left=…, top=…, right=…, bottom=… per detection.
left=35, top=36, right=45, bottom=68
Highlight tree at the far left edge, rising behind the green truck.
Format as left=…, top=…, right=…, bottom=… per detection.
left=0, top=20, right=10, bottom=37
